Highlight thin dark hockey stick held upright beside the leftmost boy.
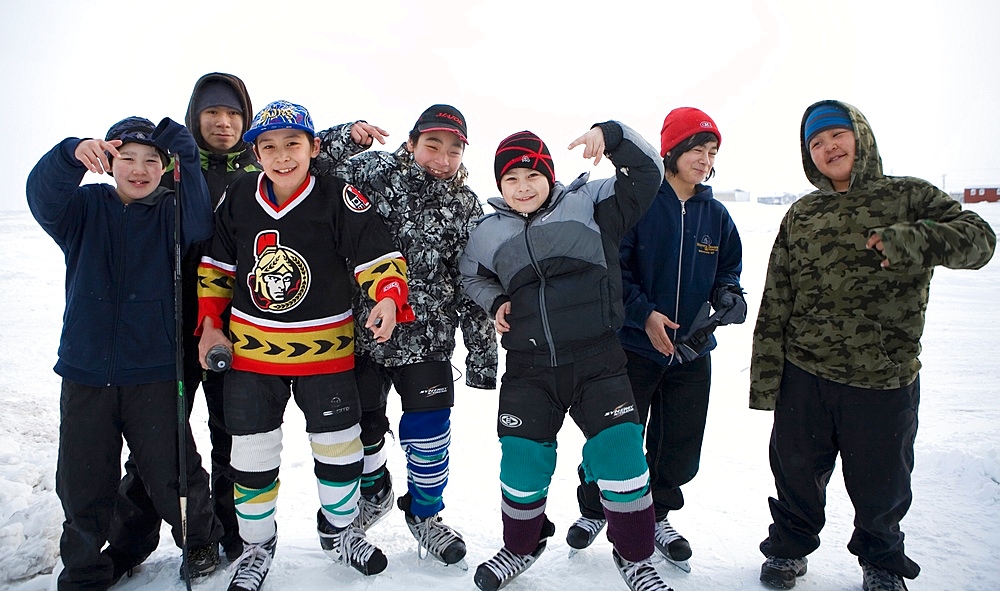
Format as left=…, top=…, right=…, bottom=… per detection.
left=174, top=154, right=191, bottom=591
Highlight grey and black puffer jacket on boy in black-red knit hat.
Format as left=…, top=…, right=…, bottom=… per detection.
left=461, top=121, right=663, bottom=367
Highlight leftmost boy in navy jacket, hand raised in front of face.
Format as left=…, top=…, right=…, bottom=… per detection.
left=27, top=117, right=222, bottom=591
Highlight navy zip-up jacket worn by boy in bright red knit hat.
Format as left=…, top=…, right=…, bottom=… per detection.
left=618, top=181, right=743, bottom=365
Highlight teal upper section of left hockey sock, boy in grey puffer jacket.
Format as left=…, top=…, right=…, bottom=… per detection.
left=500, top=436, right=557, bottom=504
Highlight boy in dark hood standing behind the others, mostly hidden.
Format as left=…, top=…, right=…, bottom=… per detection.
left=109, top=72, right=260, bottom=572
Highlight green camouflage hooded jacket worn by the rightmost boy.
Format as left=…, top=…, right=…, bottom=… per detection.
left=750, top=101, right=996, bottom=410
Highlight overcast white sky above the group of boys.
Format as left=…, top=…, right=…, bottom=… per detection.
left=0, top=0, right=1000, bottom=211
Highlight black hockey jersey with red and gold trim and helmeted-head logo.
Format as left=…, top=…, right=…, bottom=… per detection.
left=198, top=173, right=413, bottom=376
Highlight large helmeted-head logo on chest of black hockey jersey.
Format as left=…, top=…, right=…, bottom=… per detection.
left=247, top=230, right=312, bottom=314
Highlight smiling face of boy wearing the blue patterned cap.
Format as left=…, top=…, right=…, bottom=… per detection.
left=253, top=129, right=320, bottom=202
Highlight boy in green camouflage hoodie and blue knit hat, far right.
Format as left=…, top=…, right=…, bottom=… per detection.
left=750, top=101, right=996, bottom=590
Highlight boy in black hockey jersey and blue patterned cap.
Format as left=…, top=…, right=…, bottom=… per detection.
left=199, top=101, right=413, bottom=591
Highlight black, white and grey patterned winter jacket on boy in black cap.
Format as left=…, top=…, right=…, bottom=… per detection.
left=313, top=124, right=497, bottom=388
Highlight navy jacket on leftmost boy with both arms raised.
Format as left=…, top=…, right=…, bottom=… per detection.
left=27, top=120, right=212, bottom=386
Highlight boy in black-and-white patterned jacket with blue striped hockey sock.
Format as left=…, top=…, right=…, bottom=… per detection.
left=314, top=105, right=497, bottom=564
